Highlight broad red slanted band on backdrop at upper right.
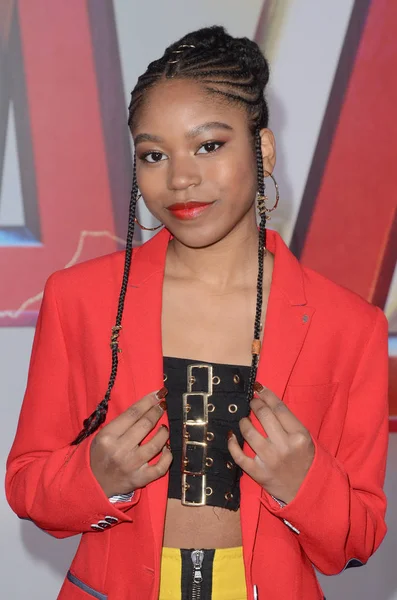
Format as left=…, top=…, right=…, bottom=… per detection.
left=301, top=0, right=397, bottom=422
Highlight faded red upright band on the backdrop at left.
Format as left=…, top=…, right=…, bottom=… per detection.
left=0, top=0, right=116, bottom=318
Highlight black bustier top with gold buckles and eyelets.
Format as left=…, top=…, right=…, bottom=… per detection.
left=164, top=357, right=250, bottom=510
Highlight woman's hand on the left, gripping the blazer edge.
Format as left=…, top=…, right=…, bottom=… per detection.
left=91, top=388, right=172, bottom=498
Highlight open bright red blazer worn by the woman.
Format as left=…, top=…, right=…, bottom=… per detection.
left=7, top=230, right=388, bottom=600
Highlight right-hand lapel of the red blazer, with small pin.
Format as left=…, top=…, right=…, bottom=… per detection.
left=241, top=231, right=314, bottom=572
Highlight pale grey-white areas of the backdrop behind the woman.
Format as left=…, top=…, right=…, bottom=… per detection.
left=0, top=0, right=397, bottom=600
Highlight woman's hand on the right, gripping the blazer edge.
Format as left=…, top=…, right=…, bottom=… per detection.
left=228, top=383, right=314, bottom=504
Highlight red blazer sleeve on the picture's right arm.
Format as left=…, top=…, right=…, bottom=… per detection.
left=261, top=308, right=388, bottom=575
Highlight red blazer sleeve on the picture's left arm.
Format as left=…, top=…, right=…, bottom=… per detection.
left=6, top=274, right=140, bottom=538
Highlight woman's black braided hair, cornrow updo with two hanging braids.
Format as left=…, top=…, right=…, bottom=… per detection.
left=72, top=26, right=269, bottom=444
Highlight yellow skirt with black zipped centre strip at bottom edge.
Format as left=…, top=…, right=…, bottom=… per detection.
left=159, top=547, right=247, bottom=600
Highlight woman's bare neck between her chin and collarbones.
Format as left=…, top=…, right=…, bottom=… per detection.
left=168, top=213, right=258, bottom=293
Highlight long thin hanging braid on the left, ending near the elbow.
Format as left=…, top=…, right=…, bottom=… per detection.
left=72, top=155, right=138, bottom=445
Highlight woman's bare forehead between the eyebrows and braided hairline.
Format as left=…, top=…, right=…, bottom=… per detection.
left=133, top=79, right=248, bottom=135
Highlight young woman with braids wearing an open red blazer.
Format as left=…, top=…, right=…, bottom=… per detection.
left=7, top=27, right=387, bottom=600
